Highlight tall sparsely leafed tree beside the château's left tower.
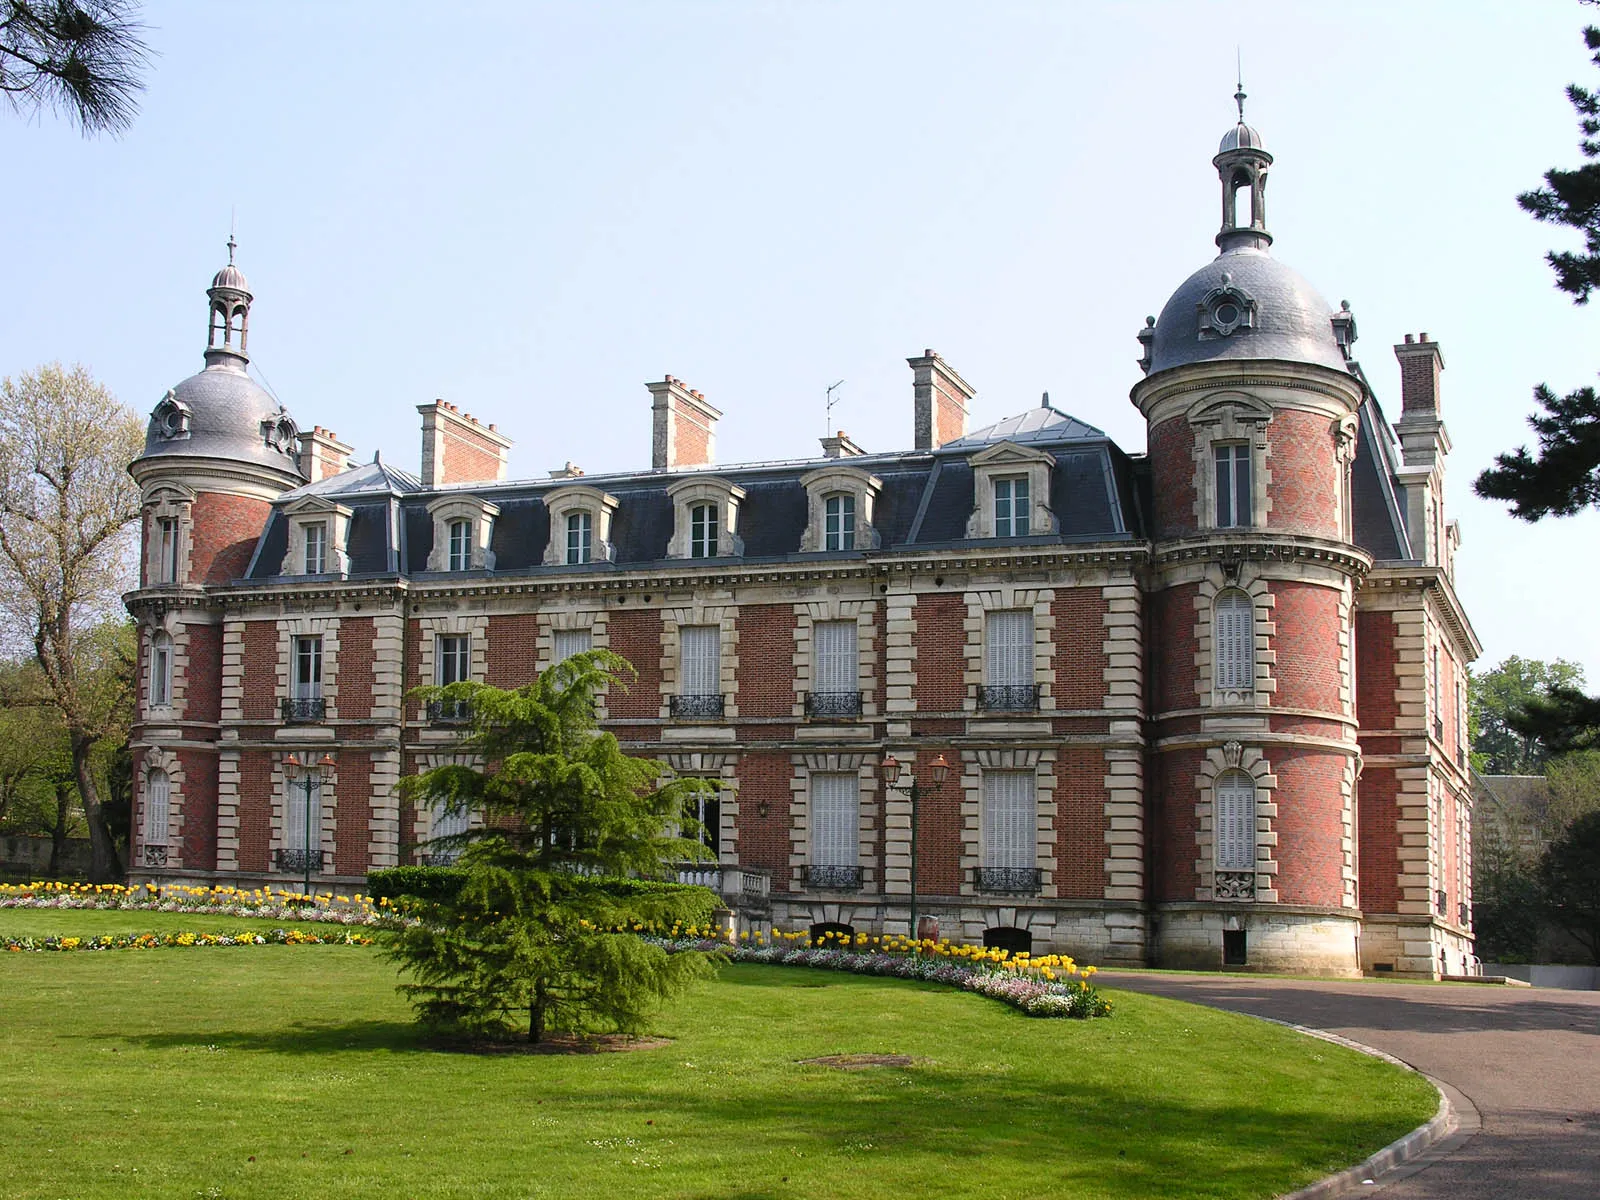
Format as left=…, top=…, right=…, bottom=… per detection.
left=0, top=363, right=144, bottom=882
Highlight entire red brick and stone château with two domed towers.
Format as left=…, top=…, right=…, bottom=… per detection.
left=126, top=101, right=1478, bottom=976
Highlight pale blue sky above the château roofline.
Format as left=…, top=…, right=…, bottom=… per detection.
left=0, top=0, right=1600, bottom=683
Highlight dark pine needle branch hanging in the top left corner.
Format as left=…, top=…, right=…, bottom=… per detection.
left=0, top=0, right=150, bottom=134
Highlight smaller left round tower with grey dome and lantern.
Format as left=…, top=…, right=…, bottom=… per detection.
left=126, top=238, right=306, bottom=878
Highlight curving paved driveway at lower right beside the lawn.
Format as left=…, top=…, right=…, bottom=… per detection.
left=1099, top=971, right=1600, bottom=1200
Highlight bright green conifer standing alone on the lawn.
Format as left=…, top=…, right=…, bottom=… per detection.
left=387, top=651, right=715, bottom=1042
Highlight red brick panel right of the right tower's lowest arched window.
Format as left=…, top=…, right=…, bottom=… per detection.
left=1272, top=747, right=1346, bottom=907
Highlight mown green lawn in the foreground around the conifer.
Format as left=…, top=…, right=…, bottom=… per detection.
left=0, top=910, right=1435, bottom=1200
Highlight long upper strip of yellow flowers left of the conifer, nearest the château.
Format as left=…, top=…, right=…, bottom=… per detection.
left=0, top=883, right=390, bottom=925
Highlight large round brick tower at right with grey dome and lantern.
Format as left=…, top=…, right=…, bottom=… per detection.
left=1131, top=88, right=1371, bottom=974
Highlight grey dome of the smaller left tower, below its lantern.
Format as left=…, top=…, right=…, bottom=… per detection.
left=141, top=355, right=302, bottom=478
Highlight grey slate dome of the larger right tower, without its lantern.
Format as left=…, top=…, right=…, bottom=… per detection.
left=1150, top=248, right=1347, bottom=374
